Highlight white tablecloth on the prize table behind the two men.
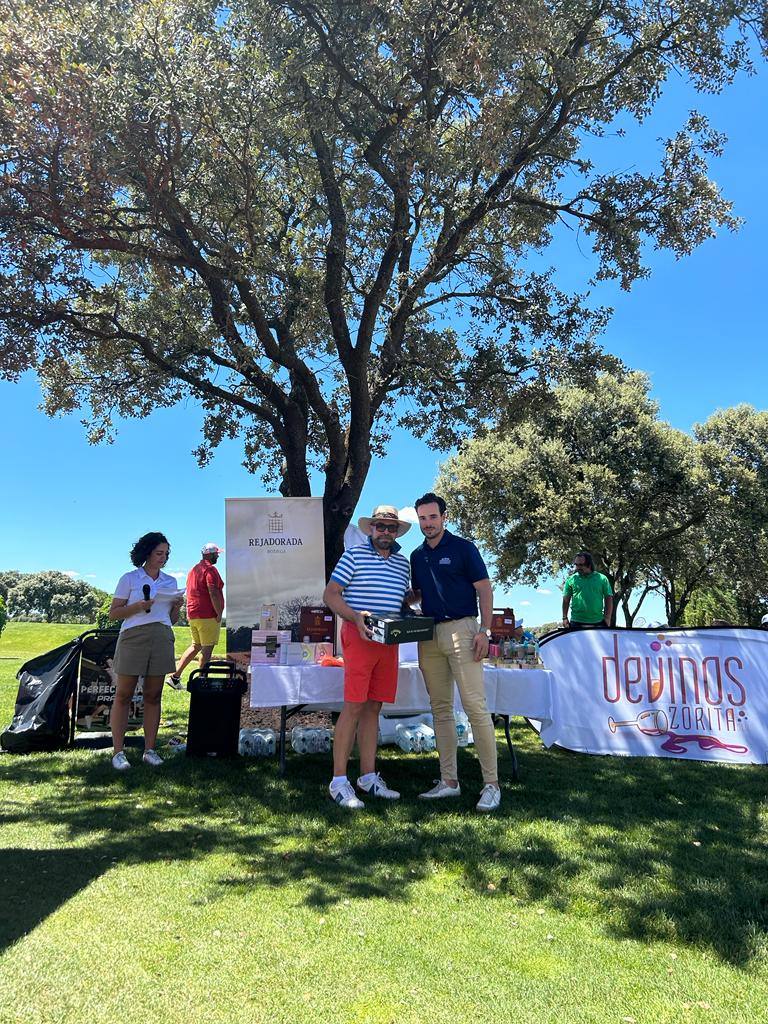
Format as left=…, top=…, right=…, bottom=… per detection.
left=250, top=664, right=554, bottom=723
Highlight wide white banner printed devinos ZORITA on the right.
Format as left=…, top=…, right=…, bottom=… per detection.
left=541, top=628, right=768, bottom=764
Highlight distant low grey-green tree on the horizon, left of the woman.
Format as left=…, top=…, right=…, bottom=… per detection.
left=7, top=571, right=104, bottom=623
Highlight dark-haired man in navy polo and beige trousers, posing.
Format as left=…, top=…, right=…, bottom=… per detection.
left=411, top=492, right=501, bottom=811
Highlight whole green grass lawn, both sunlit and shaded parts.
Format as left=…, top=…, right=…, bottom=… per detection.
left=0, top=625, right=768, bottom=1024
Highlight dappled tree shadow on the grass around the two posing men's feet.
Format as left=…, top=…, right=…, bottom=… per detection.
left=0, top=727, right=768, bottom=966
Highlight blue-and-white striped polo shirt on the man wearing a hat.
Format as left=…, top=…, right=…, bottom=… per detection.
left=331, top=539, right=411, bottom=615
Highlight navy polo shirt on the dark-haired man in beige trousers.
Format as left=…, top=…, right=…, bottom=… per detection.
left=411, top=530, right=488, bottom=623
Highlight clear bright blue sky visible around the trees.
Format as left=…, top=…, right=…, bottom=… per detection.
left=0, top=64, right=768, bottom=624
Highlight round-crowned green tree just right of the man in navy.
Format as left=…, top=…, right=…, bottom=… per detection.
left=437, top=373, right=707, bottom=626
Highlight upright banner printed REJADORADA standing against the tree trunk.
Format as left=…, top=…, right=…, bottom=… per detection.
left=226, top=498, right=326, bottom=660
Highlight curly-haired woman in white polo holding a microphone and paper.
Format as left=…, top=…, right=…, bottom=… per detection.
left=110, top=532, right=184, bottom=771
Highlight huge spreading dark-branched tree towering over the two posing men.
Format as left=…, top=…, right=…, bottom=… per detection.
left=0, top=0, right=765, bottom=573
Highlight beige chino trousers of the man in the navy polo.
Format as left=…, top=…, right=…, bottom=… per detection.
left=419, top=618, right=499, bottom=782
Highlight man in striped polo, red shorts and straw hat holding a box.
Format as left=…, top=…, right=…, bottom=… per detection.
left=323, top=505, right=411, bottom=810
